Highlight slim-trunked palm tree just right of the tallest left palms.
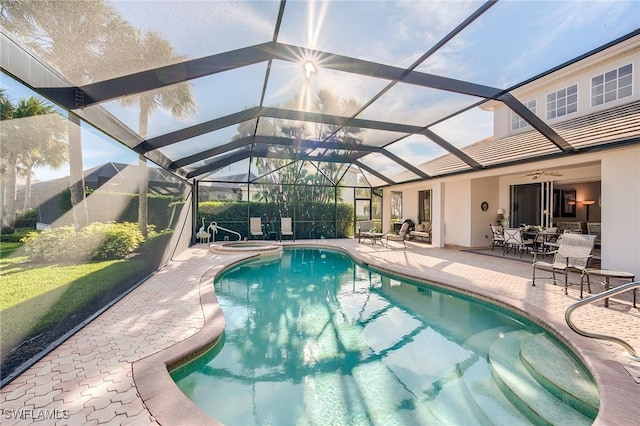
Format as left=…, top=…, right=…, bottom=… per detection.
left=112, top=26, right=196, bottom=236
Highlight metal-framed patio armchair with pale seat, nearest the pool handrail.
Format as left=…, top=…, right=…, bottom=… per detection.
left=532, top=232, right=596, bottom=294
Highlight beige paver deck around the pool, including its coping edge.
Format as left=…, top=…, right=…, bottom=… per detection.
left=0, top=239, right=640, bottom=425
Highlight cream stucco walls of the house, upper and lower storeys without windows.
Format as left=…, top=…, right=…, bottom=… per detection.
left=383, top=37, right=640, bottom=277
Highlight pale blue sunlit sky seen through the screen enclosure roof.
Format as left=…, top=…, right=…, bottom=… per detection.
left=0, top=0, right=640, bottom=185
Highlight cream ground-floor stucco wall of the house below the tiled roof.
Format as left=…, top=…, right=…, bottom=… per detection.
left=383, top=146, right=640, bottom=277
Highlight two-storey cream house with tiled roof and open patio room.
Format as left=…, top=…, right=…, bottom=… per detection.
left=383, top=36, right=640, bottom=276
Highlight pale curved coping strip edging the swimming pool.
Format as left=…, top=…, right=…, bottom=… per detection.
left=132, top=243, right=640, bottom=425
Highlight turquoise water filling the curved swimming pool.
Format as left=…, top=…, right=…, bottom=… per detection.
left=172, top=249, right=598, bottom=426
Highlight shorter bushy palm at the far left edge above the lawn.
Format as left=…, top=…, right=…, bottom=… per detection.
left=1, top=96, right=65, bottom=232
